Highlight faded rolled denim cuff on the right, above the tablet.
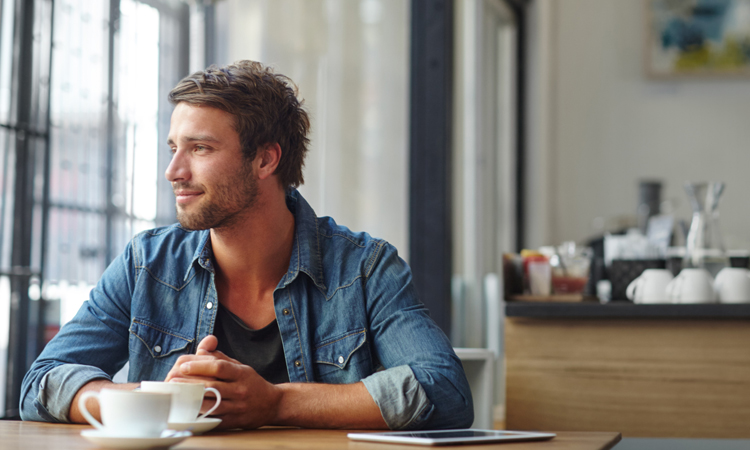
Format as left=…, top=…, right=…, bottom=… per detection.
left=362, top=365, right=435, bottom=430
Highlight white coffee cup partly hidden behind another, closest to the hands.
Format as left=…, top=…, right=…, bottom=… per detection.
left=141, top=381, right=221, bottom=423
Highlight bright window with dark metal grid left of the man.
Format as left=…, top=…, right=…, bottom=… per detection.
left=0, top=0, right=189, bottom=416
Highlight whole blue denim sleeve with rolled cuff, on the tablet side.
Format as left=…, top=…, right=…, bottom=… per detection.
left=363, top=243, right=474, bottom=429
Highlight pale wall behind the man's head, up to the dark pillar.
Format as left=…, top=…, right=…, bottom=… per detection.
left=216, top=0, right=410, bottom=260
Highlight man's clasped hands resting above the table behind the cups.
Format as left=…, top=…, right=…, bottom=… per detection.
left=164, top=335, right=282, bottom=429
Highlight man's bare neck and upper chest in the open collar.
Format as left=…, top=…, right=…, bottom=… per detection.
left=211, top=188, right=294, bottom=317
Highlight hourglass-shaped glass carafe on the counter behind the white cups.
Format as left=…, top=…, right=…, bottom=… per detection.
left=683, top=182, right=728, bottom=277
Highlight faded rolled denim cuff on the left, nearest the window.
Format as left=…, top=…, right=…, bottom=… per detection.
left=34, top=364, right=111, bottom=423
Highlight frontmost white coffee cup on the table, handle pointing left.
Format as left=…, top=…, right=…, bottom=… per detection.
left=78, top=389, right=172, bottom=438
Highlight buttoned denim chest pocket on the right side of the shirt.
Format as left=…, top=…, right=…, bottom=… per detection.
left=313, top=329, right=369, bottom=383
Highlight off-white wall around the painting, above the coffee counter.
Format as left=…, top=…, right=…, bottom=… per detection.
left=528, top=0, right=750, bottom=248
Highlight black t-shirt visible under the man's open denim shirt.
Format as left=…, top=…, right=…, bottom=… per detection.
left=214, top=307, right=289, bottom=384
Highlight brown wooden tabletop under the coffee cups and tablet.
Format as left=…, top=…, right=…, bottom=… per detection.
left=0, top=421, right=620, bottom=450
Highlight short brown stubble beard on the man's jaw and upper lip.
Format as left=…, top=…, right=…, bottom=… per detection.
left=172, top=158, right=258, bottom=230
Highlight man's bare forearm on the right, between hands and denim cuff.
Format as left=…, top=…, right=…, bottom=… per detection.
left=273, top=382, right=388, bottom=429
